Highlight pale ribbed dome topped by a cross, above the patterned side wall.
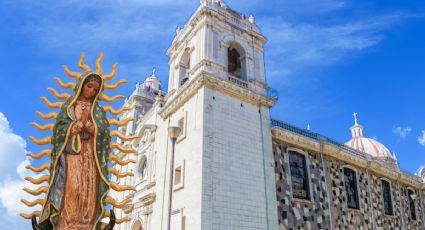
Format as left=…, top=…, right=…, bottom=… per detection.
left=345, top=113, right=397, bottom=161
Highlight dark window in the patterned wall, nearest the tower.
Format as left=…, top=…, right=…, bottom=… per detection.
left=288, top=151, right=311, bottom=200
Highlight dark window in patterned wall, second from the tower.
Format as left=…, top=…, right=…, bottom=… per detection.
left=344, top=168, right=360, bottom=209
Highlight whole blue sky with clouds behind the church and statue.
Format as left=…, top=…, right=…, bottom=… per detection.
left=0, top=0, right=425, bottom=229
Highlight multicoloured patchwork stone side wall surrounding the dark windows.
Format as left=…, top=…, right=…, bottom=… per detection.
left=273, top=141, right=425, bottom=230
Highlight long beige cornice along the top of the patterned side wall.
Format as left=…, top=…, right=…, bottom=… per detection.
left=271, top=127, right=425, bottom=189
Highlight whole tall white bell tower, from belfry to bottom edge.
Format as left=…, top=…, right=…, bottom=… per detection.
left=157, top=0, right=278, bottom=229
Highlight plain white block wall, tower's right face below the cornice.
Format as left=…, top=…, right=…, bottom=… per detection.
left=202, top=89, right=267, bottom=229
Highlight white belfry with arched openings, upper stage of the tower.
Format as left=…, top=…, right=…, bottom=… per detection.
left=167, top=0, right=267, bottom=98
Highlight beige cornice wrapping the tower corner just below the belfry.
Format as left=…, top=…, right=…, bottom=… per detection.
left=159, top=71, right=276, bottom=118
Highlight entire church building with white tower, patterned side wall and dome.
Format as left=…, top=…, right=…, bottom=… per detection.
left=111, top=0, right=425, bottom=230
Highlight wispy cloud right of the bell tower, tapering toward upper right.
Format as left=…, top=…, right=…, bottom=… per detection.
left=259, top=14, right=403, bottom=81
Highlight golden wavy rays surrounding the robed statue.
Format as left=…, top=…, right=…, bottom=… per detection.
left=21, top=52, right=137, bottom=222
